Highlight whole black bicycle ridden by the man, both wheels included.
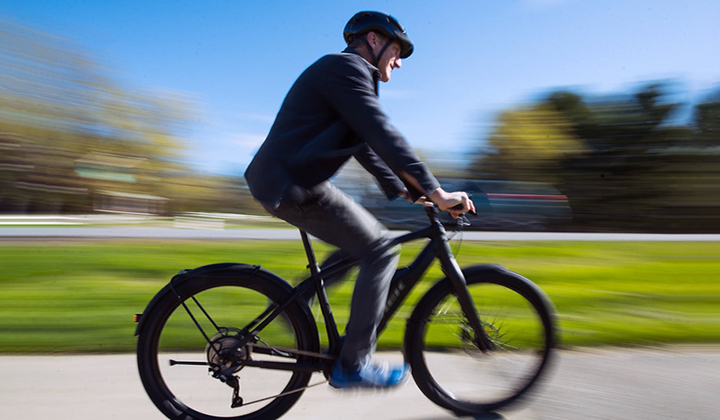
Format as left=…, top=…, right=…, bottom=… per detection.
left=136, top=207, right=557, bottom=420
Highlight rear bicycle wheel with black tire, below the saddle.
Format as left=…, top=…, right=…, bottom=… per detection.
left=137, top=268, right=319, bottom=420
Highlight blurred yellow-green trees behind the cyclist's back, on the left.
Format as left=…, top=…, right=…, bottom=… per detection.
left=0, top=18, right=195, bottom=212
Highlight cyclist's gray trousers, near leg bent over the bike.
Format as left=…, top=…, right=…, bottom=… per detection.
left=264, top=182, right=400, bottom=369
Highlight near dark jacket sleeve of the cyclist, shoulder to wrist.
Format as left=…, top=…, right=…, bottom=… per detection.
left=318, top=54, right=440, bottom=199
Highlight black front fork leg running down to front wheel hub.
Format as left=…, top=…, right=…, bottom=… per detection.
left=438, top=241, right=495, bottom=353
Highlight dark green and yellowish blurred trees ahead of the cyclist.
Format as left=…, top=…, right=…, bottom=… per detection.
left=473, top=83, right=720, bottom=231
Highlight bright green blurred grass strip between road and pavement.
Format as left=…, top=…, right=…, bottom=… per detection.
left=0, top=240, right=720, bottom=353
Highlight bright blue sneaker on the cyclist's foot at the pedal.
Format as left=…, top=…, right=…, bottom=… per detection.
left=330, top=362, right=410, bottom=389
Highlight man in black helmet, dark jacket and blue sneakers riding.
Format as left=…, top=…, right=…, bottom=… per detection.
left=245, top=12, right=475, bottom=388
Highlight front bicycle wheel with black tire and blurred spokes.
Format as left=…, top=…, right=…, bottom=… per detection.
left=404, top=265, right=557, bottom=416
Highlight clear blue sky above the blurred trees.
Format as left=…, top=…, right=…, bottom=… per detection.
left=0, top=0, right=720, bottom=174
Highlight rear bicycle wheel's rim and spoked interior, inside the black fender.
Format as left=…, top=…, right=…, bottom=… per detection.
left=146, top=286, right=309, bottom=419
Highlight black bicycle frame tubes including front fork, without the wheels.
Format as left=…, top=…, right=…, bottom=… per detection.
left=233, top=207, right=492, bottom=370
